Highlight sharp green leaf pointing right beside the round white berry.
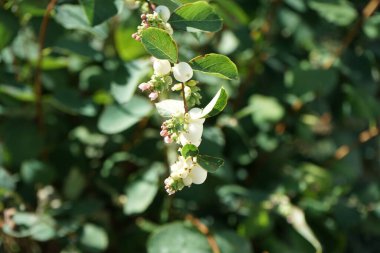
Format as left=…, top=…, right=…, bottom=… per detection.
left=190, top=54, right=239, bottom=80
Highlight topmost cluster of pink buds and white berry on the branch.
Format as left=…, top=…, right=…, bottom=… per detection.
left=132, top=5, right=173, bottom=41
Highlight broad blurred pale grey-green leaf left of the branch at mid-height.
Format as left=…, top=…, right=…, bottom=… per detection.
left=98, top=96, right=152, bottom=134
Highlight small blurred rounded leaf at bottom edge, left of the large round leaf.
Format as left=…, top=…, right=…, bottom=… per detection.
left=80, top=223, right=108, bottom=251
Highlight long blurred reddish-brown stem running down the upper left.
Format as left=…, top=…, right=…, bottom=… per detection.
left=34, top=0, right=57, bottom=129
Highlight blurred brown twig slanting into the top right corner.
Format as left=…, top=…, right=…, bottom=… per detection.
left=323, top=0, right=380, bottom=69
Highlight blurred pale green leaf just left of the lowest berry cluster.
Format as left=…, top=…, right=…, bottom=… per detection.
left=124, top=163, right=165, bottom=215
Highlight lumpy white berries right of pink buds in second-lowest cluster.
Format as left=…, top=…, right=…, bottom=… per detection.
left=179, top=108, right=205, bottom=147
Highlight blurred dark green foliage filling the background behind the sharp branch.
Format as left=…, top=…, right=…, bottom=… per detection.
left=0, top=0, right=380, bottom=253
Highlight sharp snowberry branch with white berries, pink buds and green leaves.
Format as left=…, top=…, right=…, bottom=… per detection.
left=132, top=0, right=238, bottom=194
